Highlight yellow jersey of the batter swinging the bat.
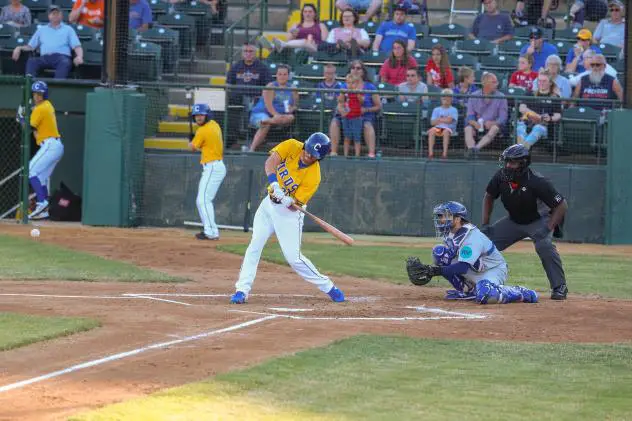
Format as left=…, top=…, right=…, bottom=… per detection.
left=270, top=139, right=320, bottom=205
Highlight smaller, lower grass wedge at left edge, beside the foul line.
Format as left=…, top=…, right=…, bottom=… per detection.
left=0, top=313, right=101, bottom=351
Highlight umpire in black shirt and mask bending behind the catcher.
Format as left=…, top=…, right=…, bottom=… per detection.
left=481, top=145, right=568, bottom=300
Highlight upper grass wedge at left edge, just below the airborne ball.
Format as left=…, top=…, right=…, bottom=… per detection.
left=0, top=235, right=184, bottom=282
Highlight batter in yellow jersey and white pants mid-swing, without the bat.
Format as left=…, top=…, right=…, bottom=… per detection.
left=230, top=133, right=345, bottom=304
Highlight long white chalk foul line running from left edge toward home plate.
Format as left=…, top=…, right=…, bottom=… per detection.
left=0, top=314, right=279, bottom=393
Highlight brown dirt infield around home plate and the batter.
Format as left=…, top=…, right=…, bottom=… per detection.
left=0, top=225, right=632, bottom=420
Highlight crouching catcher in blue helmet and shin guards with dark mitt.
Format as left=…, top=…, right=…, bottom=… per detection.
left=406, top=202, right=538, bottom=304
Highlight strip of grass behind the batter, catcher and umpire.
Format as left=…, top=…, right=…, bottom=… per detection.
left=217, top=243, right=632, bottom=298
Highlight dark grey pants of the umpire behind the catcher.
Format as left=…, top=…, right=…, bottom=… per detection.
left=487, top=215, right=566, bottom=289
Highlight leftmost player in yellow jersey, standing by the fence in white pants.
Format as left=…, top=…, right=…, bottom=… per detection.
left=29, top=80, right=64, bottom=219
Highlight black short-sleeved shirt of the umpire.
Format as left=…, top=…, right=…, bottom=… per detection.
left=487, top=169, right=564, bottom=225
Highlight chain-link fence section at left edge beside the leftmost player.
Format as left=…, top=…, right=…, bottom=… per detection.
left=0, top=76, right=31, bottom=225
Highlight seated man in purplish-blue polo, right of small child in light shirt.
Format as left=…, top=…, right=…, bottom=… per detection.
left=465, top=73, right=508, bottom=154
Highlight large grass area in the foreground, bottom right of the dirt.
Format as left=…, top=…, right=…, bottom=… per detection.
left=72, top=336, right=632, bottom=421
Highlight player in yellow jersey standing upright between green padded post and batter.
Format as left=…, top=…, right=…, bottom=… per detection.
left=189, top=104, right=226, bottom=240
